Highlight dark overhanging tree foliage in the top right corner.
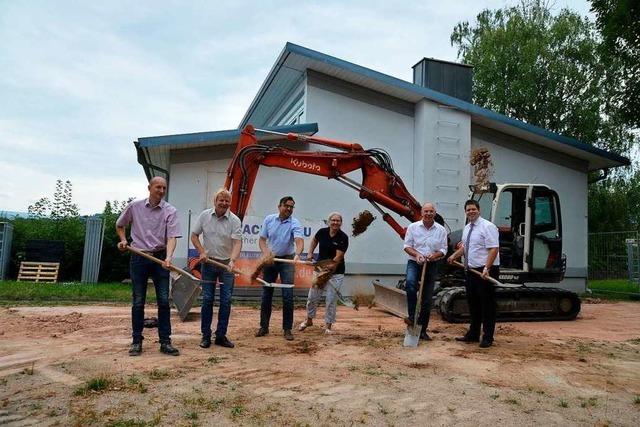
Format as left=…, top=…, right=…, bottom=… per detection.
left=591, top=0, right=640, bottom=128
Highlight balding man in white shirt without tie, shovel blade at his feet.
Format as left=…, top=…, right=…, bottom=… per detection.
left=404, top=202, right=447, bottom=341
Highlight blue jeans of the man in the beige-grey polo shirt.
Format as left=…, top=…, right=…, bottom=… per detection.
left=200, top=264, right=235, bottom=339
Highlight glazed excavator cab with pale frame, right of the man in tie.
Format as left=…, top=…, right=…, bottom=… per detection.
left=470, top=183, right=566, bottom=283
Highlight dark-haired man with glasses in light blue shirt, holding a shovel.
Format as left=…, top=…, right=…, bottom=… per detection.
left=256, top=196, right=304, bottom=341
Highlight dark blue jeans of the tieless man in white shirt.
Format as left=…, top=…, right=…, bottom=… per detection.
left=405, top=259, right=438, bottom=331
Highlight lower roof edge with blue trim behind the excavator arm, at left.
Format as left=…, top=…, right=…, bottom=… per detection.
left=134, top=123, right=318, bottom=179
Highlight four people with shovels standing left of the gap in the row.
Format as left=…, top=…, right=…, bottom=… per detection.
left=116, top=177, right=349, bottom=356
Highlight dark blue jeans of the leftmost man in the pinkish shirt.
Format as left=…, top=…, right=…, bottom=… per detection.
left=130, top=252, right=171, bottom=343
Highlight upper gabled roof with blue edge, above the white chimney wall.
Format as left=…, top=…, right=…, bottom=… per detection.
left=240, top=43, right=630, bottom=170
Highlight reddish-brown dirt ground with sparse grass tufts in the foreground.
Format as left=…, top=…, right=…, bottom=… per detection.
left=0, top=303, right=640, bottom=426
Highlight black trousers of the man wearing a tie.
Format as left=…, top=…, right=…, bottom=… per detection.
left=465, top=265, right=500, bottom=341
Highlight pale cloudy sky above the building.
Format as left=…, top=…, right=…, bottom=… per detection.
left=0, top=0, right=590, bottom=214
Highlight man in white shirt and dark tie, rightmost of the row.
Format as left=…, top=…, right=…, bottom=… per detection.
left=448, top=200, right=500, bottom=348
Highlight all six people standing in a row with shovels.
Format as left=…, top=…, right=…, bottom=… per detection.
left=116, top=177, right=500, bottom=356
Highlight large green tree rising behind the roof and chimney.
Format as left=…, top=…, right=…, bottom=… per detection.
left=451, top=0, right=634, bottom=153
